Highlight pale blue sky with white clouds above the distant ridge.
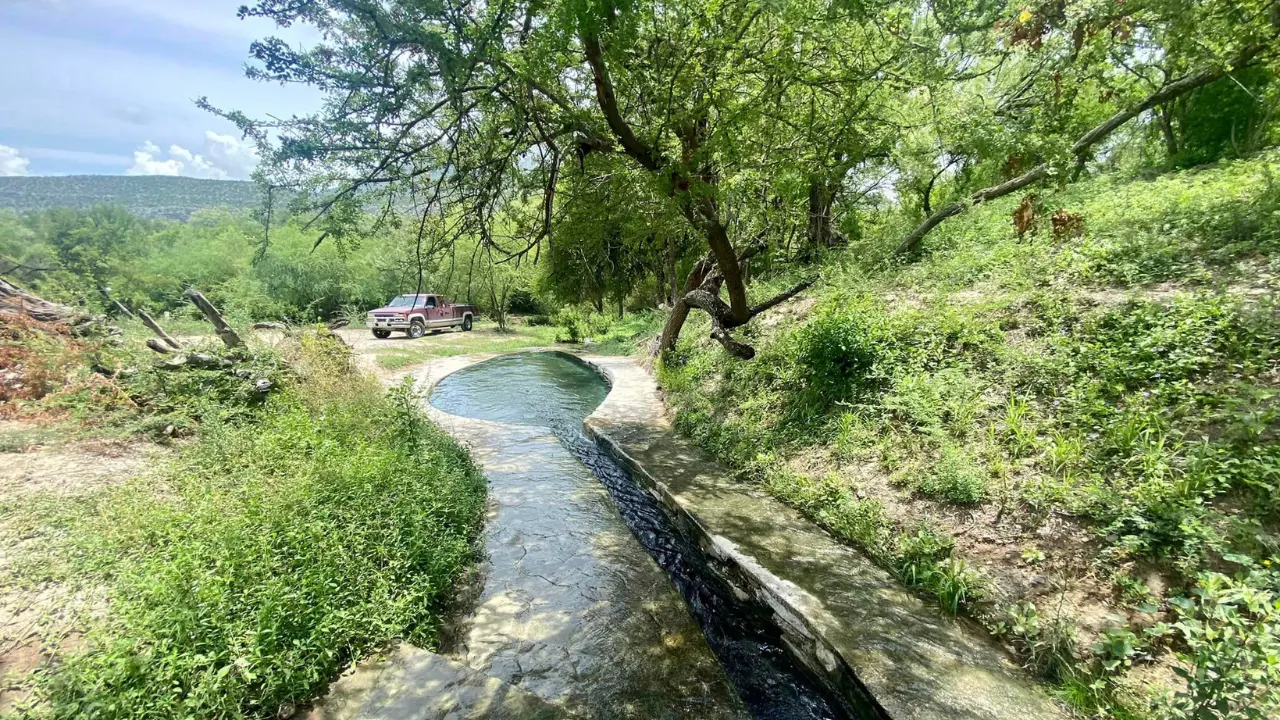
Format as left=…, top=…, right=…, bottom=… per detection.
left=0, top=0, right=320, bottom=179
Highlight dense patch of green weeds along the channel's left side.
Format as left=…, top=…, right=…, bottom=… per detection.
left=5, top=336, right=485, bottom=719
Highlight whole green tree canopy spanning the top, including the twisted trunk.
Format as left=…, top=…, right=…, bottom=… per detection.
left=212, top=0, right=1280, bottom=357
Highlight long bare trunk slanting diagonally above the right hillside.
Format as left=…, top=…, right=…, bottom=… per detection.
left=893, top=45, right=1263, bottom=254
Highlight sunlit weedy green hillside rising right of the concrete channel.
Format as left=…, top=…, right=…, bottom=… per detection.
left=659, top=154, right=1280, bottom=717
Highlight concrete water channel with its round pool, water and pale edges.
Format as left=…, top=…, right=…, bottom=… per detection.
left=314, top=352, right=1066, bottom=720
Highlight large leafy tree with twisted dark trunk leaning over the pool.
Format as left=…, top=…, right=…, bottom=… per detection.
left=215, top=0, right=952, bottom=357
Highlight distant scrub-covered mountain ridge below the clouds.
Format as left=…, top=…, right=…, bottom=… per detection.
left=0, top=176, right=262, bottom=220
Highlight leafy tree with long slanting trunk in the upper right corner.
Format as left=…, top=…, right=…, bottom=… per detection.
left=899, top=0, right=1280, bottom=252
